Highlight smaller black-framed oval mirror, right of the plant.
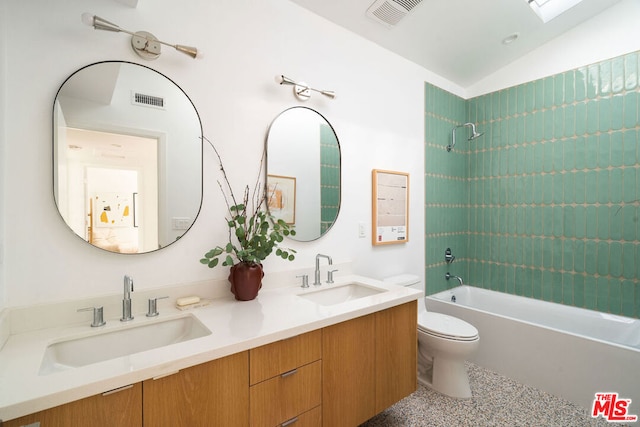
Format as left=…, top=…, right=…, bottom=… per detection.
left=267, top=107, right=341, bottom=242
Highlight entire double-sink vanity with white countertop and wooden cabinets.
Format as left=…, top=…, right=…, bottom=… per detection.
left=0, top=275, right=420, bottom=426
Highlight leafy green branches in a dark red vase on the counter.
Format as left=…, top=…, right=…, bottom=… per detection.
left=200, top=138, right=296, bottom=301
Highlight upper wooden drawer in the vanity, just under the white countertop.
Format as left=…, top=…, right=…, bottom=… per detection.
left=249, top=330, right=322, bottom=385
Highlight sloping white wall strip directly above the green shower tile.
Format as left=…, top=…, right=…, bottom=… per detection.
left=465, top=0, right=640, bottom=99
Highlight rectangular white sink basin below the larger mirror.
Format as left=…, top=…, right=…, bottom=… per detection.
left=39, top=315, right=211, bottom=375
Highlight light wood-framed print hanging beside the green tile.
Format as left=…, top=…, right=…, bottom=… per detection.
left=371, top=169, right=409, bottom=246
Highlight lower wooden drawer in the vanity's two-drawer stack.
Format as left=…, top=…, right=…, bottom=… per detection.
left=249, top=361, right=322, bottom=427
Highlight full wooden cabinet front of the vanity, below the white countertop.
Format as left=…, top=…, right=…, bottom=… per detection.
left=3, top=301, right=417, bottom=427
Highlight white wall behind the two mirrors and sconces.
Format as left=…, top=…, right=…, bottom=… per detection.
left=0, top=0, right=444, bottom=307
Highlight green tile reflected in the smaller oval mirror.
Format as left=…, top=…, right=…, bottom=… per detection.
left=320, top=124, right=340, bottom=233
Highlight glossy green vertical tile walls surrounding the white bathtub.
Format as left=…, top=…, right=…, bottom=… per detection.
left=425, top=52, right=640, bottom=317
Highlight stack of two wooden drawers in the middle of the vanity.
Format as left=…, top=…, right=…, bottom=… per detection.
left=249, top=330, right=322, bottom=427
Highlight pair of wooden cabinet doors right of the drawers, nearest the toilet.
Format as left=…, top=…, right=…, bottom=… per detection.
left=322, top=301, right=417, bottom=427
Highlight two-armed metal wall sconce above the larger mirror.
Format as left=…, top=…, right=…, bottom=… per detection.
left=82, top=12, right=202, bottom=60
